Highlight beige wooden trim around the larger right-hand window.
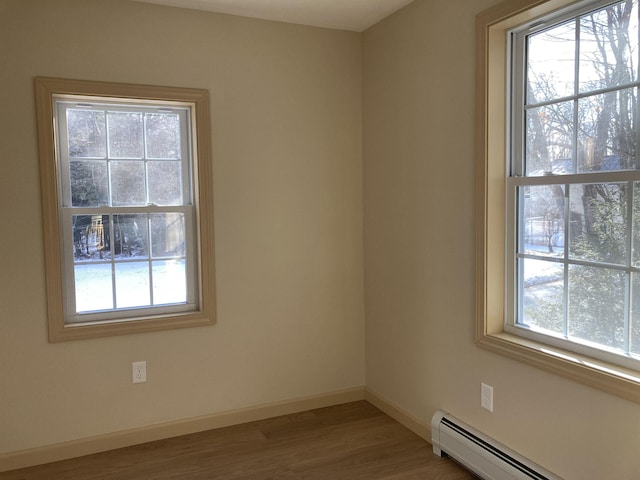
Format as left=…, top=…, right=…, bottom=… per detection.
left=476, top=0, right=640, bottom=403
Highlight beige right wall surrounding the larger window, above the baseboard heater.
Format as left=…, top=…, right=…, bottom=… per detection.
left=363, top=0, right=640, bottom=480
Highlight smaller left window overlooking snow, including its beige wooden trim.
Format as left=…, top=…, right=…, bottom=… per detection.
left=36, top=78, right=214, bottom=341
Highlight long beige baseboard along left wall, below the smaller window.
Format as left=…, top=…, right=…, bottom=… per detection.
left=0, top=387, right=364, bottom=472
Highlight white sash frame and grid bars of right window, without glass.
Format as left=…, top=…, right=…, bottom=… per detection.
left=505, top=1, right=640, bottom=369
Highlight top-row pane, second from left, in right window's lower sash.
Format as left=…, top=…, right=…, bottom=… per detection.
left=569, top=183, right=627, bottom=265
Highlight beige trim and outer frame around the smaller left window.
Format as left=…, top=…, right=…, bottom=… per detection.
left=35, top=78, right=215, bottom=342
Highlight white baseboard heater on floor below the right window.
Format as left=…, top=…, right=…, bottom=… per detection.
left=431, top=410, right=561, bottom=480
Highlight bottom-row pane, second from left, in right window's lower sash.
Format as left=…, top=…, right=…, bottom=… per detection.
left=568, top=265, right=625, bottom=349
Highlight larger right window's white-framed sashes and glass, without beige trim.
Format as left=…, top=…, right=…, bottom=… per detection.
left=505, top=0, right=640, bottom=369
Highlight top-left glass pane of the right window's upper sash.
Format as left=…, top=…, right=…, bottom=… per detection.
left=526, top=21, right=576, bottom=105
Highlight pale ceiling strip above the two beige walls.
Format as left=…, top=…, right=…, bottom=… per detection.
left=130, top=0, right=413, bottom=32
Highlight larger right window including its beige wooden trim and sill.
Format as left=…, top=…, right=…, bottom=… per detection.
left=476, top=0, right=640, bottom=401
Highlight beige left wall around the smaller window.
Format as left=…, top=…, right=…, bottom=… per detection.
left=0, top=0, right=364, bottom=454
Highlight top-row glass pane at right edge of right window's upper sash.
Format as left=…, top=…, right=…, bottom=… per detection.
left=579, top=0, right=638, bottom=92
